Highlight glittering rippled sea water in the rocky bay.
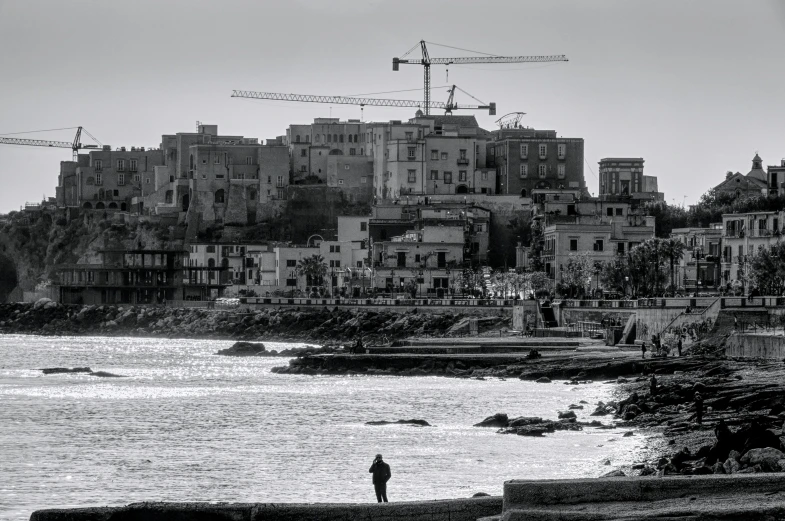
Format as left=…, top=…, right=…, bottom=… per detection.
left=0, top=336, right=645, bottom=519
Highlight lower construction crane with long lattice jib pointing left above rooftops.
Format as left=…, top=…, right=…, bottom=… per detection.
left=232, top=85, right=496, bottom=116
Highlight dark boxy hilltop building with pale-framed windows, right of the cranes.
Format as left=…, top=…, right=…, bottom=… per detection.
left=488, top=128, right=586, bottom=197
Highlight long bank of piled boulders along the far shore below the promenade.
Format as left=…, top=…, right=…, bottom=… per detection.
left=0, top=301, right=500, bottom=343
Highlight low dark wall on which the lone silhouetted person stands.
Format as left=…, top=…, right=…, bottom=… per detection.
left=30, top=497, right=502, bottom=521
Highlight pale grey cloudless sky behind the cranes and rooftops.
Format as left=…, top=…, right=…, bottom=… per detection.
left=0, top=0, right=785, bottom=212
